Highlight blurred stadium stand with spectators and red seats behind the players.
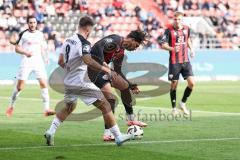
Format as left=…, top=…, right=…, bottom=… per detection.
left=0, top=0, right=240, bottom=52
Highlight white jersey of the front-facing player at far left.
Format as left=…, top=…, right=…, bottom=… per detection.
left=16, top=30, right=46, bottom=67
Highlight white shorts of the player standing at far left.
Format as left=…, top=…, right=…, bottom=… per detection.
left=16, top=66, right=47, bottom=80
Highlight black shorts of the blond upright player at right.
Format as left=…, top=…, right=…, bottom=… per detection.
left=168, top=62, right=193, bottom=81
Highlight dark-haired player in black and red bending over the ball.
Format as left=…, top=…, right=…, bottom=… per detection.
left=88, top=30, right=147, bottom=141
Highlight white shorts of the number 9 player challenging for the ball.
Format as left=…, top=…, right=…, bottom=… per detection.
left=64, top=83, right=104, bottom=105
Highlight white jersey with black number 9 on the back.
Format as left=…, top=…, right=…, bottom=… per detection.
left=60, top=34, right=91, bottom=87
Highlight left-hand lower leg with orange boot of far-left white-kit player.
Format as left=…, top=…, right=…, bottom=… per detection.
left=6, top=80, right=25, bottom=117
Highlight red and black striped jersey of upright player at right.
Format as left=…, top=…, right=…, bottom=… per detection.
left=160, top=25, right=190, bottom=64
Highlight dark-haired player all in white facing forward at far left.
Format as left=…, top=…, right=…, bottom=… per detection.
left=6, top=16, right=55, bottom=117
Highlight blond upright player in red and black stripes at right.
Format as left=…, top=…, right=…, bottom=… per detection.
left=160, top=12, right=195, bottom=115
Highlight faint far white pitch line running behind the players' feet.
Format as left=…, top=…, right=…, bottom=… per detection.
left=0, top=96, right=240, bottom=116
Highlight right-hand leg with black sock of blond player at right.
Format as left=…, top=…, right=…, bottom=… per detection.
left=179, top=76, right=195, bottom=115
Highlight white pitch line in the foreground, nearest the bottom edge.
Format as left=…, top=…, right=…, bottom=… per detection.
left=0, top=137, right=240, bottom=151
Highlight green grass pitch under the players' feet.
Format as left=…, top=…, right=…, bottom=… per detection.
left=0, top=81, right=240, bottom=160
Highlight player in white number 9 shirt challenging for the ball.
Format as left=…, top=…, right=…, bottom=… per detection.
left=44, top=16, right=133, bottom=146
